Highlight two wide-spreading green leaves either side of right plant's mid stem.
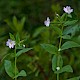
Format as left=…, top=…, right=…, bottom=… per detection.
left=41, top=41, right=80, bottom=54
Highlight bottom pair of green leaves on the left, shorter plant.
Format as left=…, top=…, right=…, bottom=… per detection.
left=4, top=60, right=27, bottom=79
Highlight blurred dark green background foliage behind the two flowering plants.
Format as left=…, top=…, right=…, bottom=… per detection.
left=0, top=0, right=80, bottom=80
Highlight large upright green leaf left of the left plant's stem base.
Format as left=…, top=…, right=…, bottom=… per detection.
left=4, top=60, right=14, bottom=78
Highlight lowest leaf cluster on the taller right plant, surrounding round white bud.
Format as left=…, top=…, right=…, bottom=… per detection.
left=52, top=55, right=73, bottom=73
